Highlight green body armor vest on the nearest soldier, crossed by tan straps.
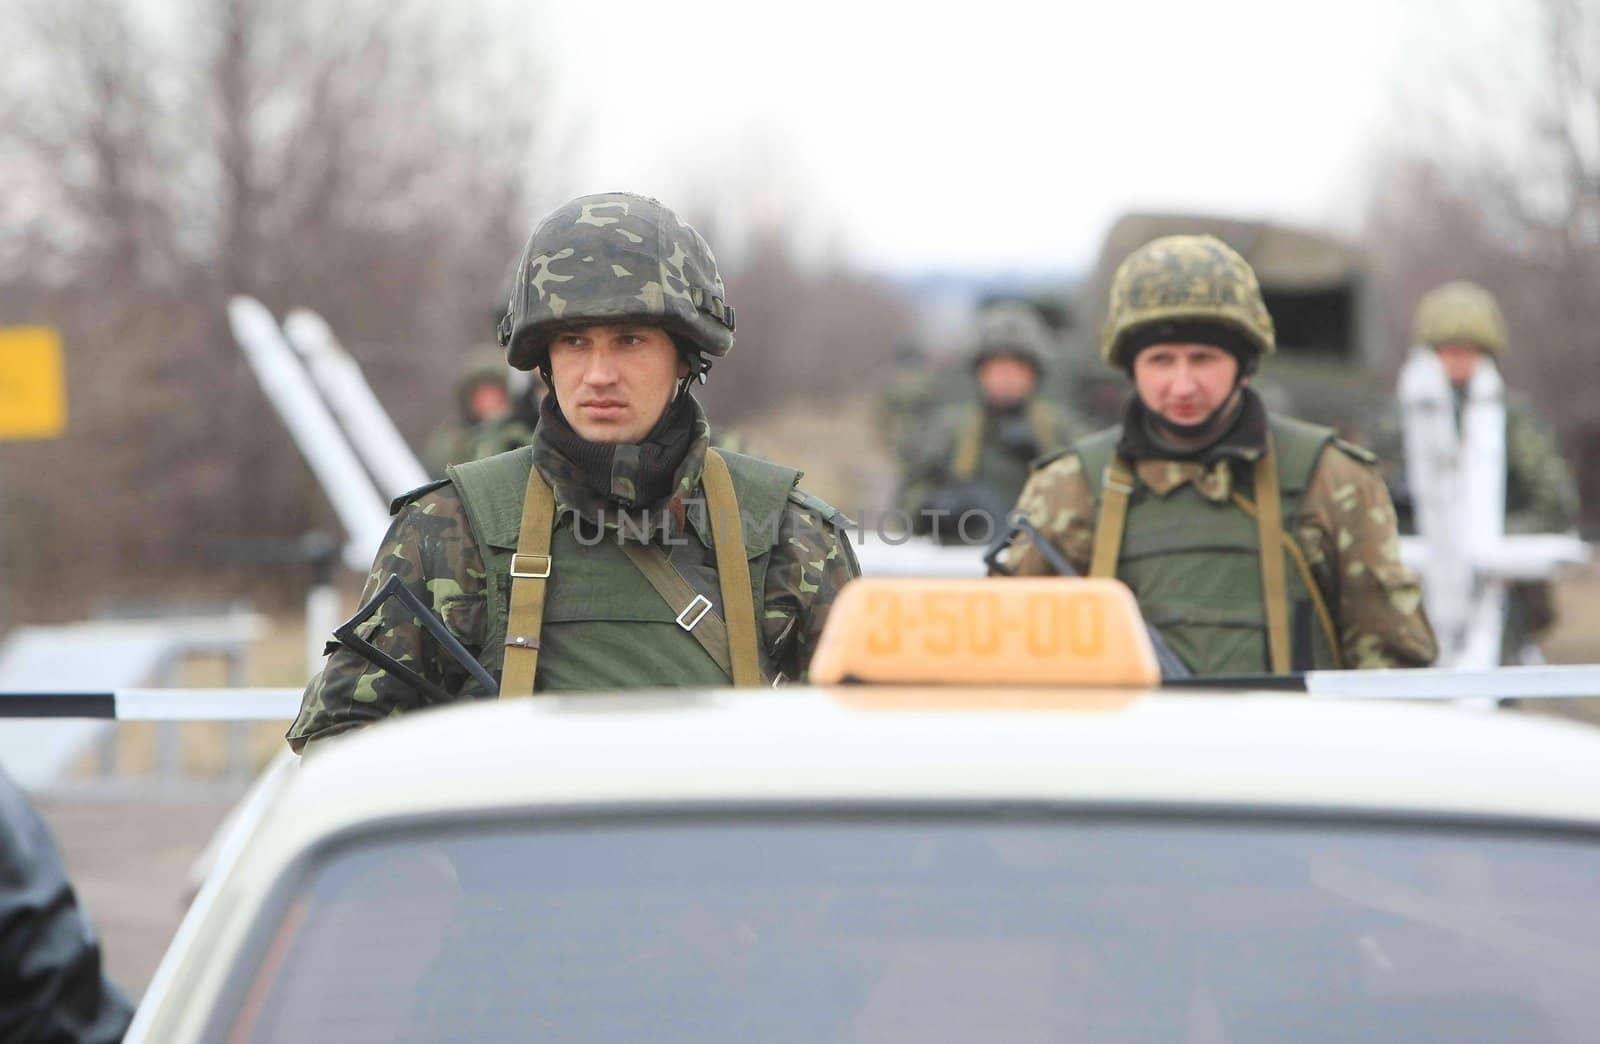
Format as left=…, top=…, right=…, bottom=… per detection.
left=446, top=447, right=800, bottom=692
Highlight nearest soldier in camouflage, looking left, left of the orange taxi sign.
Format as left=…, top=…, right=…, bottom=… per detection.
left=288, top=194, right=859, bottom=749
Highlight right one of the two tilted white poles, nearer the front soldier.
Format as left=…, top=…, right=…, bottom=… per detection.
left=283, top=309, right=429, bottom=500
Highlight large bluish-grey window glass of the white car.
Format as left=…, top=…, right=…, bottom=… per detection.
left=224, top=813, right=1600, bottom=1044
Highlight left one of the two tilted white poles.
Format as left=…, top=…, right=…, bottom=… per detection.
left=227, top=296, right=389, bottom=572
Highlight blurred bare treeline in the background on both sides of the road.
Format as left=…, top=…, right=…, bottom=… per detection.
left=0, top=0, right=1600, bottom=626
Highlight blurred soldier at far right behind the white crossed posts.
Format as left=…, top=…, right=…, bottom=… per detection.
left=1401, top=280, right=1578, bottom=663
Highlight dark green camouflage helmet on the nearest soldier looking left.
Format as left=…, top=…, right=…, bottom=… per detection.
left=499, top=192, right=733, bottom=370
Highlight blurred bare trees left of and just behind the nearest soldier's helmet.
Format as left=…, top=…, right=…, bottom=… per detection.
left=0, top=0, right=902, bottom=626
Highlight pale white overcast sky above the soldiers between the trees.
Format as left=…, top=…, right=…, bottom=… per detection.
left=539, top=0, right=1497, bottom=269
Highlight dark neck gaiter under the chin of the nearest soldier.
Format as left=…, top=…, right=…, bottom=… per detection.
left=536, top=391, right=694, bottom=508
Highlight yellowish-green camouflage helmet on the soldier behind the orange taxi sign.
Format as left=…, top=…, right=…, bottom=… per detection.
left=1101, top=235, right=1274, bottom=371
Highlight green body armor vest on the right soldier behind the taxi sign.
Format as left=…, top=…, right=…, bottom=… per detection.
left=1074, top=416, right=1338, bottom=674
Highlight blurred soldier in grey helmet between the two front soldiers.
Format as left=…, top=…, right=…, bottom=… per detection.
left=901, top=301, right=1083, bottom=543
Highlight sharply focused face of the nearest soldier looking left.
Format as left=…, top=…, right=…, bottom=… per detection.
left=550, top=323, right=690, bottom=442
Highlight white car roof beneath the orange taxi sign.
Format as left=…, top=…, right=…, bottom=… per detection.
left=274, top=687, right=1600, bottom=844
